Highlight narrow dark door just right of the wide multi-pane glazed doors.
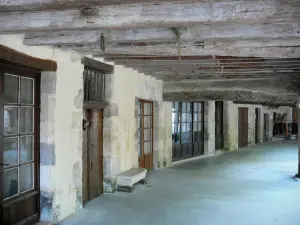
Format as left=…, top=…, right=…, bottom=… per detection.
left=215, top=101, right=224, bottom=149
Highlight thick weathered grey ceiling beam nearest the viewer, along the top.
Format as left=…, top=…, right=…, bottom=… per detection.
left=0, top=0, right=300, bottom=33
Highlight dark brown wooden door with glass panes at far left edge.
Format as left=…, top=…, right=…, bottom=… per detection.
left=0, top=62, right=40, bottom=225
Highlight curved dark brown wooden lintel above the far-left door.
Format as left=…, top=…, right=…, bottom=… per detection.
left=0, top=44, right=57, bottom=71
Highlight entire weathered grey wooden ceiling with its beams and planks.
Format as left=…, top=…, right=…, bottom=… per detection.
left=0, top=0, right=300, bottom=105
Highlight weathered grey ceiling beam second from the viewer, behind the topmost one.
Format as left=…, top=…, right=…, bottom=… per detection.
left=24, top=23, right=300, bottom=47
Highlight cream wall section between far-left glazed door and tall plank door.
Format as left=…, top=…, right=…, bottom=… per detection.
left=0, top=35, right=83, bottom=221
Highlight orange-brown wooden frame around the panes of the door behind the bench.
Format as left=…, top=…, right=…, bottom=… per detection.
left=138, top=99, right=154, bottom=169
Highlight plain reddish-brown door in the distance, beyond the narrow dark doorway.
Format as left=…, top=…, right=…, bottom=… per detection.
left=238, top=108, right=248, bottom=148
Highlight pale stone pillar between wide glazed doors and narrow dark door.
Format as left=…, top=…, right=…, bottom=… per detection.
left=204, top=101, right=215, bottom=155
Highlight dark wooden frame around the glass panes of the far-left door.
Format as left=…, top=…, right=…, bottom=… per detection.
left=0, top=59, right=41, bottom=225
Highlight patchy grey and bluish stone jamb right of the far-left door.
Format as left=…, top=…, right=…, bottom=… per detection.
left=40, top=72, right=56, bottom=221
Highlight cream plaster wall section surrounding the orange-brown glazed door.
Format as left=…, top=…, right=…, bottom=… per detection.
left=103, top=62, right=172, bottom=192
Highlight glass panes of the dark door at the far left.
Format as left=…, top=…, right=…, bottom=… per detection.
left=3, top=74, right=35, bottom=200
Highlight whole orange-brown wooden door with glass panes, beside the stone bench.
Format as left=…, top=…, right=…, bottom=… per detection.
left=138, top=99, right=153, bottom=169
